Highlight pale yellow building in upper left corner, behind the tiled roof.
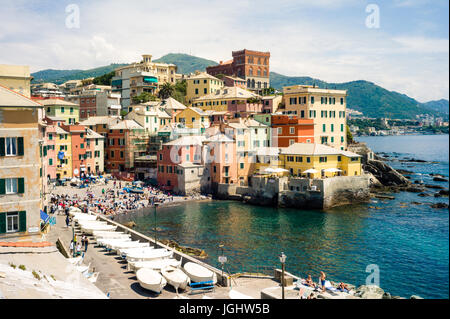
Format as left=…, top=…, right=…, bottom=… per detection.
left=0, top=64, right=32, bottom=97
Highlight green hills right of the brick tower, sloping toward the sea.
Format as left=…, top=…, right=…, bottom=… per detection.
left=270, top=72, right=448, bottom=118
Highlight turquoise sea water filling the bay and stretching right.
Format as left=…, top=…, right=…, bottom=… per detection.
left=132, top=135, right=449, bottom=298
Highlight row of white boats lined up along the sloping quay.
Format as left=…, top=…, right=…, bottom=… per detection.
left=69, top=207, right=217, bottom=294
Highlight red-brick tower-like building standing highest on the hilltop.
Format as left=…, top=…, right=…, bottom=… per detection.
left=206, top=49, right=270, bottom=93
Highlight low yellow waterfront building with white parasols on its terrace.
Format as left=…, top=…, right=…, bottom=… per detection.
left=280, top=143, right=362, bottom=178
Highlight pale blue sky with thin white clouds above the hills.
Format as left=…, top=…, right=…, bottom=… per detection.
left=0, top=0, right=449, bottom=102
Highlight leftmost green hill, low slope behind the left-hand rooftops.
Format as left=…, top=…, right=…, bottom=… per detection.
left=31, top=64, right=126, bottom=84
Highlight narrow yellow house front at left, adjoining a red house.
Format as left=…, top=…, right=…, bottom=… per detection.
left=55, top=126, right=73, bottom=179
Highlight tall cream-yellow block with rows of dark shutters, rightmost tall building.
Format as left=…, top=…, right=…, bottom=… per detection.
left=283, top=85, right=347, bottom=150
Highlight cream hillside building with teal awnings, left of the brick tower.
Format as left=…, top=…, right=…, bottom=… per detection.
left=111, top=54, right=179, bottom=108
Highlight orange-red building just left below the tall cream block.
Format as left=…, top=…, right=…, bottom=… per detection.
left=271, top=115, right=314, bottom=147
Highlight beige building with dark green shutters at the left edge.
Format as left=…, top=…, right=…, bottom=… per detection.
left=0, top=85, right=45, bottom=239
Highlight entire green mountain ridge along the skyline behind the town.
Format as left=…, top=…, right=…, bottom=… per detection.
left=32, top=53, right=448, bottom=118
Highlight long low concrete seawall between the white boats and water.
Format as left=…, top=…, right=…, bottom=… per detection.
left=97, top=215, right=230, bottom=287
